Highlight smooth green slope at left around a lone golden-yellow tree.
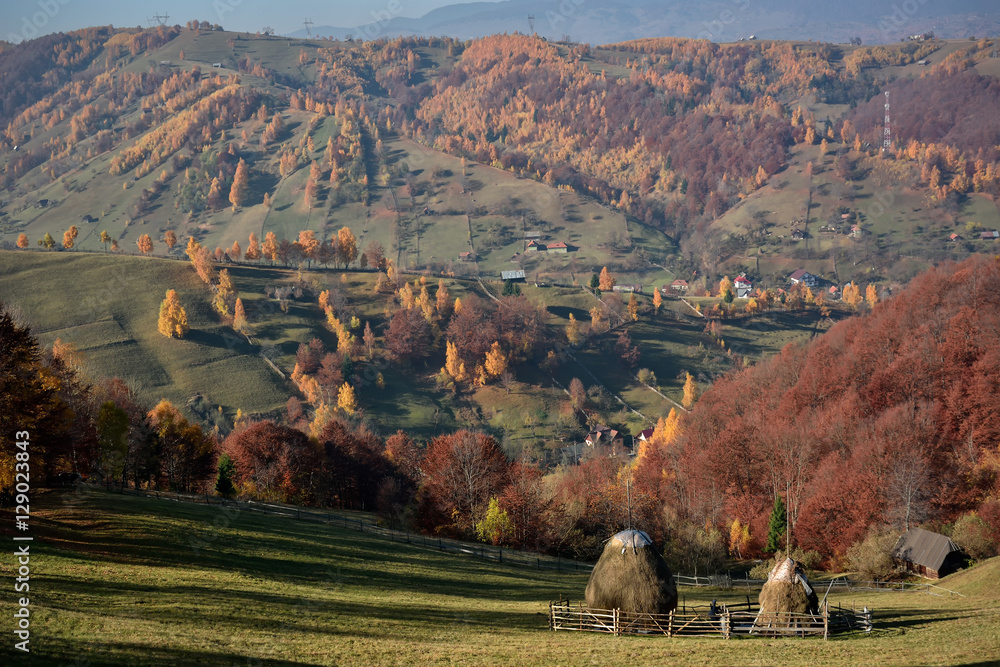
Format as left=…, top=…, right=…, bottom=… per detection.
left=0, top=252, right=288, bottom=412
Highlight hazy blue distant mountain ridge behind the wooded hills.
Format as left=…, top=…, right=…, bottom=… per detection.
left=289, top=0, right=1000, bottom=45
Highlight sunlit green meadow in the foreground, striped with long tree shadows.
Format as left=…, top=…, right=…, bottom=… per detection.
left=0, top=490, right=1000, bottom=666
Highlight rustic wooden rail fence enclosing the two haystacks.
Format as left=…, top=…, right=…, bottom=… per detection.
left=549, top=600, right=872, bottom=639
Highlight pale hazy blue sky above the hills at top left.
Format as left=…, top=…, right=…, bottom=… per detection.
left=0, top=0, right=495, bottom=42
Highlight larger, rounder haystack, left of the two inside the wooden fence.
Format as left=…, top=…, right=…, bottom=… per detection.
left=586, top=530, right=677, bottom=614
